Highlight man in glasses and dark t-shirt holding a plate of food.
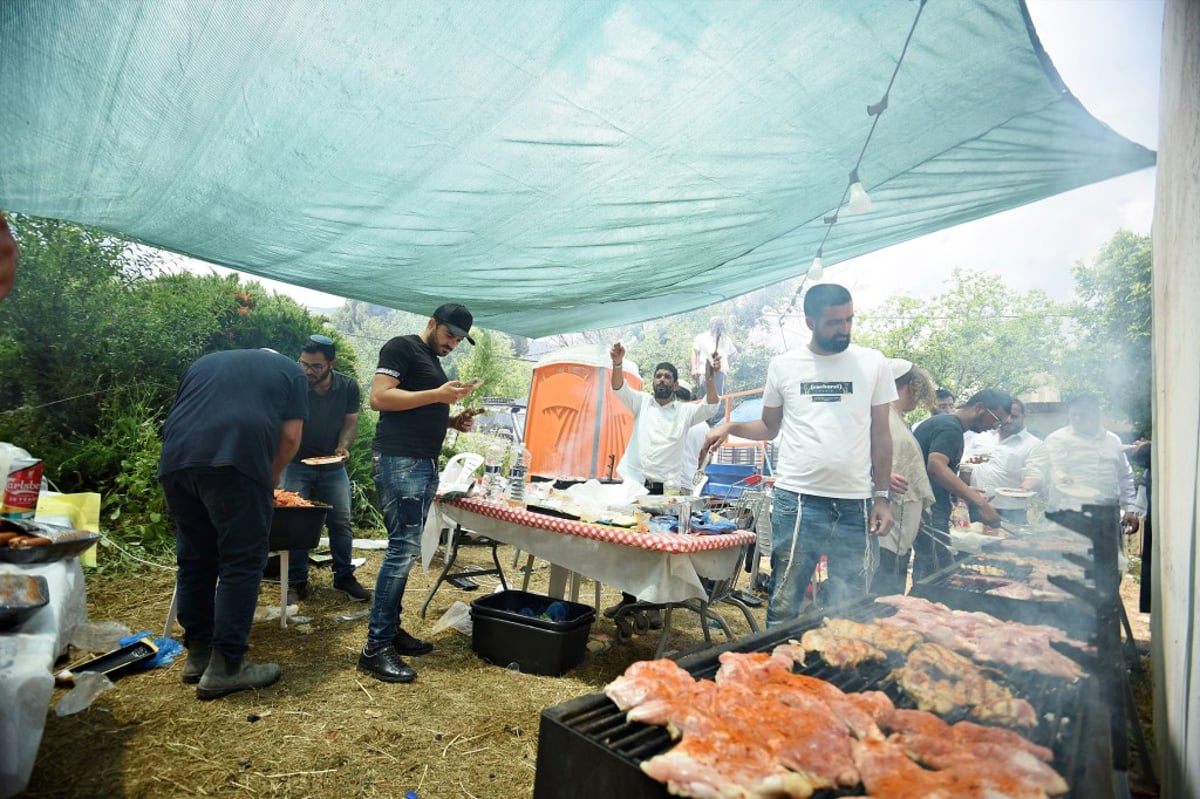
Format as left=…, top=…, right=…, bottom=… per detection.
left=281, top=335, right=371, bottom=605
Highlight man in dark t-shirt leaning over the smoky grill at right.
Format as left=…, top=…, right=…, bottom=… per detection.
left=912, top=389, right=1013, bottom=582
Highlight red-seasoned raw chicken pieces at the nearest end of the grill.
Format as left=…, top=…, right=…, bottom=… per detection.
left=606, top=644, right=1067, bottom=799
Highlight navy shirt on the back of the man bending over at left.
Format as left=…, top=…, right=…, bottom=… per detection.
left=158, top=349, right=308, bottom=486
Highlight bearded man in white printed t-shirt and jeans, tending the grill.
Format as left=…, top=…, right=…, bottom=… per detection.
left=703, top=283, right=896, bottom=626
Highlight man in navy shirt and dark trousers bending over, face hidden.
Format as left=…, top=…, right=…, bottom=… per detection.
left=158, top=349, right=308, bottom=699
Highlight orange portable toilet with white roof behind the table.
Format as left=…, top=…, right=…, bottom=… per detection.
left=524, top=344, right=642, bottom=480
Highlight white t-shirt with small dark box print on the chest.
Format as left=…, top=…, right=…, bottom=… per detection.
left=762, top=344, right=896, bottom=499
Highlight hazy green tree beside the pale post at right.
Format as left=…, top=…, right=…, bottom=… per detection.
left=1064, top=230, right=1153, bottom=434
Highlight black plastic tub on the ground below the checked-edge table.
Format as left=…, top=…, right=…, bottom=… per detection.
left=470, top=590, right=596, bottom=677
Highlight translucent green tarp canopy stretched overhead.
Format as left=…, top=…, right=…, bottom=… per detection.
left=0, top=0, right=1154, bottom=336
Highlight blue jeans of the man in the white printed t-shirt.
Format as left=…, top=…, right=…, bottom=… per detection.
left=767, top=488, right=866, bottom=627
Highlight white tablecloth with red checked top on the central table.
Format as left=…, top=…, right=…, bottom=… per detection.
left=421, top=499, right=755, bottom=602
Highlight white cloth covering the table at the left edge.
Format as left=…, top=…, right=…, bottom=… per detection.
left=0, top=558, right=88, bottom=798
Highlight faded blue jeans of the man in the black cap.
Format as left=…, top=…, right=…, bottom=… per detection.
left=367, top=452, right=438, bottom=650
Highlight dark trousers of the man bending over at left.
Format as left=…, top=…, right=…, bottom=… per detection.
left=162, top=467, right=275, bottom=661
